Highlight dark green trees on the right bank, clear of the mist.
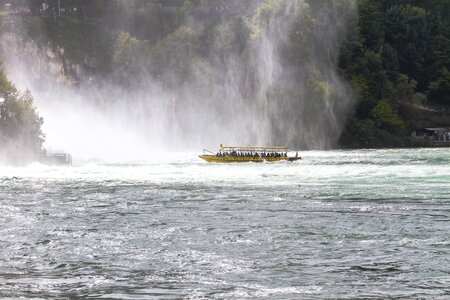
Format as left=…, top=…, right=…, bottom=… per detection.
left=340, top=0, right=450, bottom=147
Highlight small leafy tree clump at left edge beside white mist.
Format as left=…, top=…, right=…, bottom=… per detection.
left=0, top=70, right=44, bottom=164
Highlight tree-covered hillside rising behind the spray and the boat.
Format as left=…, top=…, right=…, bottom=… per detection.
left=1, top=0, right=450, bottom=148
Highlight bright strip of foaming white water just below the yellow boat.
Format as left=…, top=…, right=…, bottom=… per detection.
left=0, top=149, right=450, bottom=193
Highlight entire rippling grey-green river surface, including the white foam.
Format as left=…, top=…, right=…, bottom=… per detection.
left=0, top=149, right=450, bottom=299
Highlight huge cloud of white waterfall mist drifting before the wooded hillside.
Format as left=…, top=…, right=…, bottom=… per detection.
left=1, top=0, right=356, bottom=161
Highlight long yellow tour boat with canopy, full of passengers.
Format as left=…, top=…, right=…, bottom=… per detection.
left=199, top=144, right=301, bottom=162
